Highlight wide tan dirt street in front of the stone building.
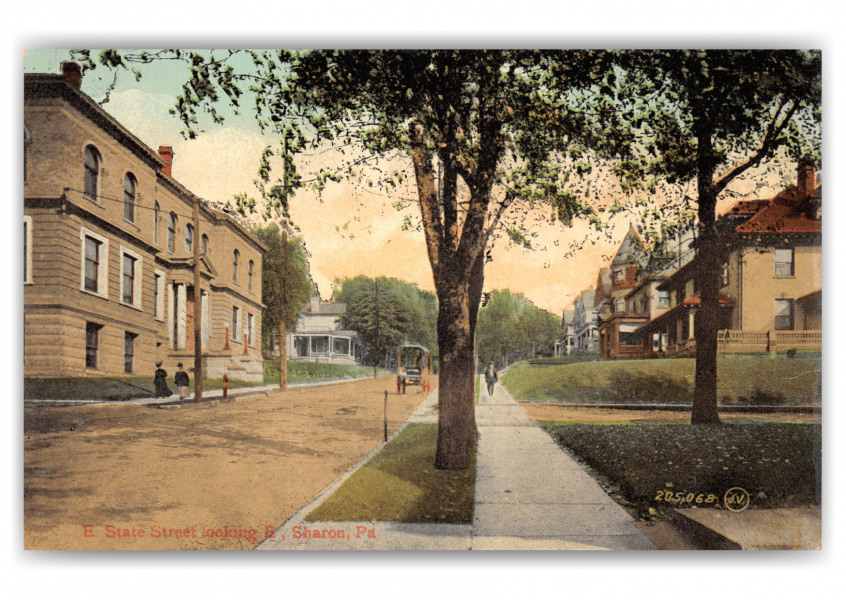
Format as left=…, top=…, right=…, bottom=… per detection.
left=24, top=376, right=437, bottom=550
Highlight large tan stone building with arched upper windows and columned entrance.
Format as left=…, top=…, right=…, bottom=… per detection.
left=24, top=63, right=266, bottom=380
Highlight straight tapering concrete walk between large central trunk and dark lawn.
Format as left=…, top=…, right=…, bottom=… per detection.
left=472, top=381, right=655, bottom=550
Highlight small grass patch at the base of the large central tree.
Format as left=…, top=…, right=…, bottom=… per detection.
left=306, top=424, right=476, bottom=523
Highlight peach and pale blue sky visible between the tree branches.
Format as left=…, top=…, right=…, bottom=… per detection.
left=24, top=49, right=793, bottom=315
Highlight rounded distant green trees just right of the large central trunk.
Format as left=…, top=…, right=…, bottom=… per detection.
left=476, top=289, right=561, bottom=365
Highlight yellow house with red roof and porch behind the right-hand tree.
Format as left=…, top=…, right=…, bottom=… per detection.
left=638, top=161, right=822, bottom=356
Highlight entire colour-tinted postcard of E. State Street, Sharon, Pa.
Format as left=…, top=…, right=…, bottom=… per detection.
left=23, top=49, right=823, bottom=551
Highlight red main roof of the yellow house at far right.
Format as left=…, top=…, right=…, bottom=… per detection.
left=729, top=186, right=822, bottom=233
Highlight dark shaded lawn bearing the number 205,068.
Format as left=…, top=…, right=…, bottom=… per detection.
left=542, top=422, right=822, bottom=515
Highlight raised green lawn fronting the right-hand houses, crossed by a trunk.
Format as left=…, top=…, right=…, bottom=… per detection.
left=502, top=353, right=822, bottom=405
